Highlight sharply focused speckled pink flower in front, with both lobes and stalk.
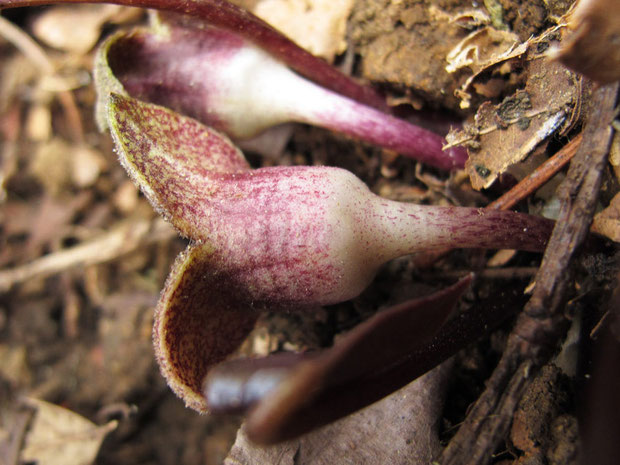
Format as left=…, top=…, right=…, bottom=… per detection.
left=108, top=94, right=551, bottom=411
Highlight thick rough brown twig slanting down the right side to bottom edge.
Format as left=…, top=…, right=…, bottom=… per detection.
left=439, top=84, right=618, bottom=465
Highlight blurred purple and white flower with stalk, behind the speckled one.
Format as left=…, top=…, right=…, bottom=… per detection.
left=95, top=24, right=467, bottom=170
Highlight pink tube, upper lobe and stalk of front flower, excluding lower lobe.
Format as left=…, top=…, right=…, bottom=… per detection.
left=112, top=92, right=550, bottom=305
